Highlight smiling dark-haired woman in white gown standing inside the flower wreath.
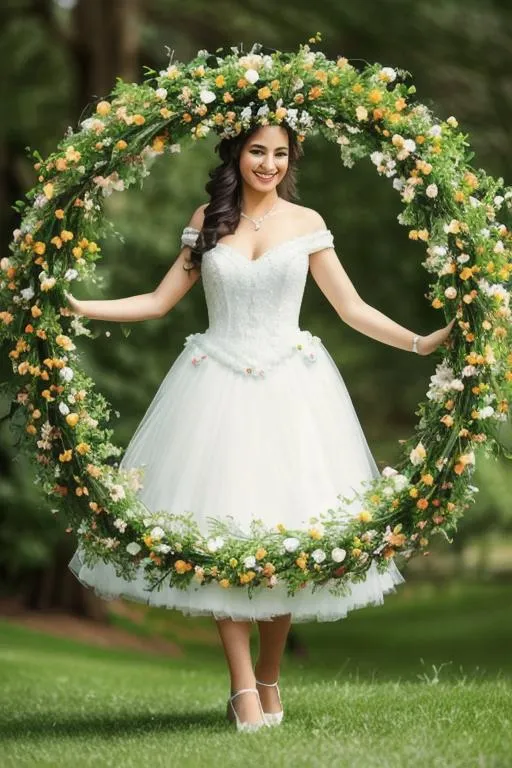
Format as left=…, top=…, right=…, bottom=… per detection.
left=68, top=121, right=453, bottom=730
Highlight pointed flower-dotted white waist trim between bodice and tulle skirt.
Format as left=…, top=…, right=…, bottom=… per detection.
left=184, top=330, right=321, bottom=378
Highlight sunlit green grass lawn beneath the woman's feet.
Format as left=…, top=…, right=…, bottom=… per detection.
left=0, top=585, right=512, bottom=768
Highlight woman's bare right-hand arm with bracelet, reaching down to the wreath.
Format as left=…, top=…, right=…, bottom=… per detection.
left=309, top=243, right=455, bottom=355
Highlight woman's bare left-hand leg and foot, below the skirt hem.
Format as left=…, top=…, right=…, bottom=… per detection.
left=216, top=619, right=261, bottom=723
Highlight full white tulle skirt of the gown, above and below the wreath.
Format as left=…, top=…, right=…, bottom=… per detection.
left=69, top=334, right=404, bottom=622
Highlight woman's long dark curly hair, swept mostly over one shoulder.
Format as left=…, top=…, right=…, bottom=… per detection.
left=184, top=125, right=302, bottom=270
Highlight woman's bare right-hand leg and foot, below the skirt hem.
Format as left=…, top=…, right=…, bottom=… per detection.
left=255, top=613, right=291, bottom=712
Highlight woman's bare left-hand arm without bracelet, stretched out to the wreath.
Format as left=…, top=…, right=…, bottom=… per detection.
left=66, top=206, right=205, bottom=323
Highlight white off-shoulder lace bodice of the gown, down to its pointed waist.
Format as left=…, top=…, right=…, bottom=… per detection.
left=181, top=227, right=333, bottom=376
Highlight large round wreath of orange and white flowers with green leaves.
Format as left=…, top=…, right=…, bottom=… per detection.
left=0, top=36, right=512, bottom=594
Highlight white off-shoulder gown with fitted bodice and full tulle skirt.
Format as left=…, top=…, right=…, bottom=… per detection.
left=69, top=227, right=404, bottom=622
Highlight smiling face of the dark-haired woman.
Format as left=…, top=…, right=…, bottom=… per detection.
left=240, top=125, right=289, bottom=192
